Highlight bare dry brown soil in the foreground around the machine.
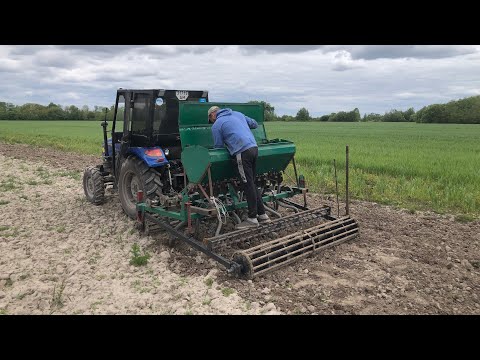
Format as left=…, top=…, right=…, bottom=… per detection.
left=0, top=144, right=480, bottom=315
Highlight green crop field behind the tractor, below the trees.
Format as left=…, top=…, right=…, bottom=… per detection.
left=0, top=121, right=480, bottom=220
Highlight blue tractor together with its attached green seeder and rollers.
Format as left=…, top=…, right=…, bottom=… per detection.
left=83, top=89, right=359, bottom=278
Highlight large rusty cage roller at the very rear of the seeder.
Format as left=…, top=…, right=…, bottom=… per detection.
left=233, top=216, right=359, bottom=278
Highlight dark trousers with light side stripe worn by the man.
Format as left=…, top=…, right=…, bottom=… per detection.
left=237, top=146, right=265, bottom=219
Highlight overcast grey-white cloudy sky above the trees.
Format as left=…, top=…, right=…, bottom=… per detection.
left=0, top=45, right=480, bottom=116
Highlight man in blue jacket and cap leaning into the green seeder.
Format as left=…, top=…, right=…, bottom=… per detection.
left=208, top=106, right=270, bottom=229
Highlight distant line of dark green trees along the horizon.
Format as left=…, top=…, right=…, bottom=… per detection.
left=0, top=96, right=480, bottom=124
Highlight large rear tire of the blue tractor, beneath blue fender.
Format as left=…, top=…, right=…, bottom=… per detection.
left=118, top=156, right=163, bottom=219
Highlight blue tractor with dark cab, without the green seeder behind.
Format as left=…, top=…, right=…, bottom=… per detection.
left=83, top=89, right=208, bottom=218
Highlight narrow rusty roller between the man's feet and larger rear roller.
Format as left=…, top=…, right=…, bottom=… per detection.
left=204, top=206, right=330, bottom=250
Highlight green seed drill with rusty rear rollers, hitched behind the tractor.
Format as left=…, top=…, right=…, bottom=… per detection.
left=133, top=103, right=359, bottom=278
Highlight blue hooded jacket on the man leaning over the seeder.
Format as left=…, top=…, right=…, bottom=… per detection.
left=212, top=109, right=258, bottom=156
